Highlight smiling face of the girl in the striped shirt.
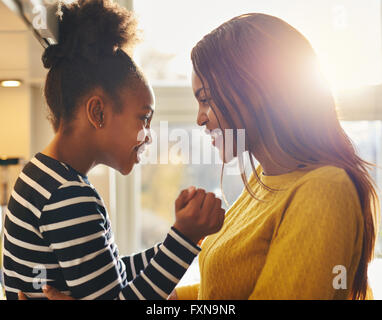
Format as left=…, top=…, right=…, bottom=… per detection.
left=101, top=83, right=155, bottom=175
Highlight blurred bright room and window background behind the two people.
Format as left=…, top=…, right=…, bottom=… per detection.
left=0, top=0, right=382, bottom=299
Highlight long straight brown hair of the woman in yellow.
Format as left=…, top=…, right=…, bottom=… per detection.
left=191, top=13, right=379, bottom=299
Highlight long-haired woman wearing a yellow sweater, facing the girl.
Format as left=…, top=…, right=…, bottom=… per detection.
left=22, top=13, right=379, bottom=299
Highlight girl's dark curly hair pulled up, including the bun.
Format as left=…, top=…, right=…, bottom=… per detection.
left=42, top=0, right=143, bottom=131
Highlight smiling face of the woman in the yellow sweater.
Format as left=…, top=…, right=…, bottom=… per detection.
left=192, top=71, right=237, bottom=163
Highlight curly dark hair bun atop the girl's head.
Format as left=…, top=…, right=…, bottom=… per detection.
left=42, top=0, right=138, bottom=68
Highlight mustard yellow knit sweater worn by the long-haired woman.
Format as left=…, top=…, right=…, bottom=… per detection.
left=176, top=166, right=363, bottom=300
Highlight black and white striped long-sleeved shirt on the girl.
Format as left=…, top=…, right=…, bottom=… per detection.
left=3, top=153, right=200, bottom=299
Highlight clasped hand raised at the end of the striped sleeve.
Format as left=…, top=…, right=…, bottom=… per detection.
left=174, top=188, right=225, bottom=244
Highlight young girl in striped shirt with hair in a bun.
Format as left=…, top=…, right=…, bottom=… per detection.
left=3, top=0, right=224, bottom=299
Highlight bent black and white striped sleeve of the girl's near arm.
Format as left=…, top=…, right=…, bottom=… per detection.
left=39, top=182, right=200, bottom=300
